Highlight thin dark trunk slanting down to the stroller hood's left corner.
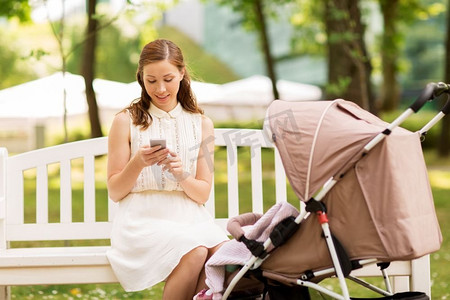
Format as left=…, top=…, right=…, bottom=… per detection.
left=254, top=0, right=280, bottom=99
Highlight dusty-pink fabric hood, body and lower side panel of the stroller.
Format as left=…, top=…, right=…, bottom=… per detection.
left=262, top=100, right=442, bottom=275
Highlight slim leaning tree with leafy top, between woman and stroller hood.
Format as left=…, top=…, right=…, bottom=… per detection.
left=212, top=0, right=290, bottom=99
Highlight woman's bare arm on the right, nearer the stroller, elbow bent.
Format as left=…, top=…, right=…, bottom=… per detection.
left=160, top=116, right=214, bottom=204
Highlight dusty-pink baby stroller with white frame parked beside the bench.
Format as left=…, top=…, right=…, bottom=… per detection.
left=206, top=83, right=450, bottom=300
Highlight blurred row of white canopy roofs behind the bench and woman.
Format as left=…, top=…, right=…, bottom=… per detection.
left=0, top=72, right=322, bottom=121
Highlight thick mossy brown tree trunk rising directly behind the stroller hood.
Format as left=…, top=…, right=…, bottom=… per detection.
left=325, top=0, right=376, bottom=113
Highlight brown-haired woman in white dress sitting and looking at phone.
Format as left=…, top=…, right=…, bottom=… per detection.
left=107, top=39, right=228, bottom=300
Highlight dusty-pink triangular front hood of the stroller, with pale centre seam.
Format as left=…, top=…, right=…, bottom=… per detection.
left=268, top=100, right=387, bottom=201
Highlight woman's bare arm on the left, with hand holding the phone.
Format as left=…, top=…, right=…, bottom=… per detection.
left=107, top=112, right=168, bottom=202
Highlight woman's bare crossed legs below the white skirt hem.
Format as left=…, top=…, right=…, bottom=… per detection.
left=163, top=247, right=209, bottom=300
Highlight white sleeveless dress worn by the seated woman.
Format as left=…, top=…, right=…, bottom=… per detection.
left=107, top=103, right=228, bottom=292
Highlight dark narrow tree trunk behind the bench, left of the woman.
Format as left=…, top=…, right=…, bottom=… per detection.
left=81, top=0, right=103, bottom=137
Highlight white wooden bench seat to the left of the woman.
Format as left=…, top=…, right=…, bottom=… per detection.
left=0, top=246, right=117, bottom=285
